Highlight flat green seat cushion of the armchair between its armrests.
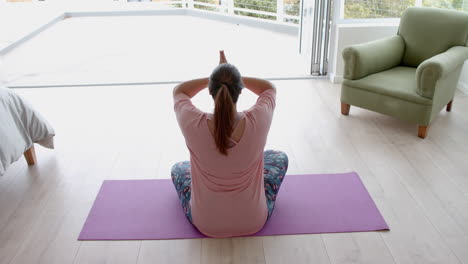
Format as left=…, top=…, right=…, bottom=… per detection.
left=343, top=67, right=432, bottom=105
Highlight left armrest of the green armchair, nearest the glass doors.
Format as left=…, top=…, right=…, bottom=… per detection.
left=343, top=35, right=405, bottom=80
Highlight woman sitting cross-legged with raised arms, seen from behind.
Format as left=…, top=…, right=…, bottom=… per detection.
left=171, top=51, right=288, bottom=237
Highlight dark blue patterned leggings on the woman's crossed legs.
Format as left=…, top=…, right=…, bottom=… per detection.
left=171, top=150, right=288, bottom=222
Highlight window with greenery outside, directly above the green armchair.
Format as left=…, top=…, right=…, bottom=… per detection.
left=344, top=0, right=468, bottom=19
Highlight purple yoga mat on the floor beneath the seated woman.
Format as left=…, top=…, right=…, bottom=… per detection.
left=78, top=172, right=388, bottom=240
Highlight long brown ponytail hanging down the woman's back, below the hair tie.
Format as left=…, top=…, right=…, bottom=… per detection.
left=213, top=84, right=235, bottom=155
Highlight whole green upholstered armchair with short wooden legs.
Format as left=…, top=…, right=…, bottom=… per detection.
left=341, top=7, right=468, bottom=138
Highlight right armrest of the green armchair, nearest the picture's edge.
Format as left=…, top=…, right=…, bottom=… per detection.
left=416, top=46, right=468, bottom=99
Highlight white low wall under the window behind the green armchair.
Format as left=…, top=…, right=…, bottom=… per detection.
left=330, top=21, right=468, bottom=94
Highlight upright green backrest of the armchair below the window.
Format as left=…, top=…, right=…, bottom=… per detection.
left=398, top=7, right=468, bottom=67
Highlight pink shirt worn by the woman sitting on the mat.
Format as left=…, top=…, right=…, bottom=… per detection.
left=174, top=89, right=276, bottom=237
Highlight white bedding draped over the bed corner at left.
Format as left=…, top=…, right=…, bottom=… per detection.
left=0, top=87, right=55, bottom=176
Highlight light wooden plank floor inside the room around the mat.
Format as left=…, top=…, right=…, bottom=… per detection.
left=0, top=80, right=468, bottom=264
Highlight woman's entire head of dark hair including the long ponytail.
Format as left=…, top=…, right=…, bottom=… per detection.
left=208, top=63, right=244, bottom=155
